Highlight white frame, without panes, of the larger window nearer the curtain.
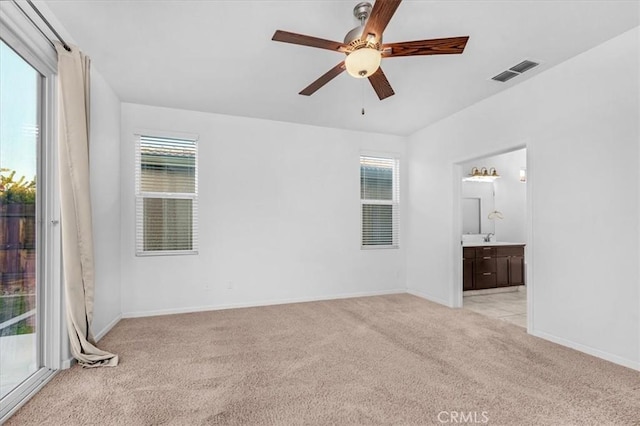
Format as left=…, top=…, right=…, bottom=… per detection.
left=134, top=129, right=199, bottom=257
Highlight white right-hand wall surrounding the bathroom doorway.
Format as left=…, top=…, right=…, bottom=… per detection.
left=406, top=28, right=640, bottom=368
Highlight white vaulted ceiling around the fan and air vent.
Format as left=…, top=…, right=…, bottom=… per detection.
left=46, top=0, right=640, bottom=135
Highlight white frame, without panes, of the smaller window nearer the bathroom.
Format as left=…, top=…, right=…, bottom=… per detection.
left=358, top=151, right=401, bottom=250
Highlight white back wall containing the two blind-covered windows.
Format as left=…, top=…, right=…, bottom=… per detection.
left=121, top=103, right=405, bottom=316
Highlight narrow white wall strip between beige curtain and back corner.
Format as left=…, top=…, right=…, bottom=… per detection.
left=89, top=68, right=122, bottom=338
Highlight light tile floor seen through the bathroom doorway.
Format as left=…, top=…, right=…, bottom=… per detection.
left=462, top=286, right=527, bottom=328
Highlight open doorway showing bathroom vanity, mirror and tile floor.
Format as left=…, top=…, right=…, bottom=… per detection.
left=459, top=148, right=527, bottom=328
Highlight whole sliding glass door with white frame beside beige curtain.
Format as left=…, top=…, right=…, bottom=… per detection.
left=0, top=0, right=60, bottom=418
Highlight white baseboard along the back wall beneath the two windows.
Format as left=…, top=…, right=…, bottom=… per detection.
left=122, top=288, right=407, bottom=318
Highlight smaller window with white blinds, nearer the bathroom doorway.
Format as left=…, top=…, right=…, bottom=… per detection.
left=360, top=156, right=400, bottom=248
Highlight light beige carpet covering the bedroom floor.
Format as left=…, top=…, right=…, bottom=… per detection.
left=8, top=294, right=640, bottom=426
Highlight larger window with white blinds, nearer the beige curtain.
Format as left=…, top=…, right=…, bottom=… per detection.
left=136, top=135, right=198, bottom=255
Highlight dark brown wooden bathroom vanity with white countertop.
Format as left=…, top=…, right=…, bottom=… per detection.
left=462, top=242, right=525, bottom=290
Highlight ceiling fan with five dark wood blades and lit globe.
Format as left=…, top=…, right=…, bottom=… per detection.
left=271, top=0, right=469, bottom=100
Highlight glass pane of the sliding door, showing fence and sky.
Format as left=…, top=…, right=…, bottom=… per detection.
left=0, top=37, right=43, bottom=398
